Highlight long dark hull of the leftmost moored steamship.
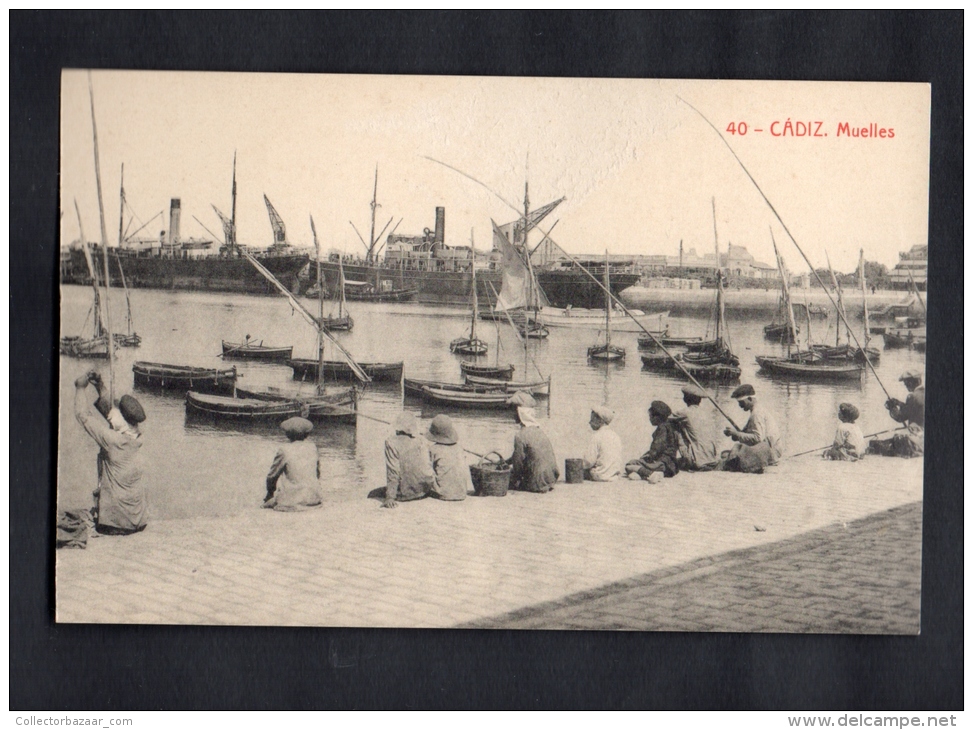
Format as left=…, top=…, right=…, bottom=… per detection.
left=64, top=250, right=310, bottom=294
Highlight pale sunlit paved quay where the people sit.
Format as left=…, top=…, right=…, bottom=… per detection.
left=56, top=457, right=922, bottom=631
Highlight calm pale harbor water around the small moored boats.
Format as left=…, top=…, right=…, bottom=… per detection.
left=58, top=286, right=925, bottom=520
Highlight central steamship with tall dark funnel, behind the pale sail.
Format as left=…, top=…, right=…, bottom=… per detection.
left=321, top=205, right=639, bottom=309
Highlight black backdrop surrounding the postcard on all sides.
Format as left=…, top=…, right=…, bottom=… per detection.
left=9, top=11, right=963, bottom=710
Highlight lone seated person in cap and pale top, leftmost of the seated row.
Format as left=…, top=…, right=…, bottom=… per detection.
left=264, top=417, right=322, bottom=512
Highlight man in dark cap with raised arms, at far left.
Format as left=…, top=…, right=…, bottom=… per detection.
left=74, top=371, right=148, bottom=535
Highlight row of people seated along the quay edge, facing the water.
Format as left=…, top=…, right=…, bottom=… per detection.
left=264, top=371, right=924, bottom=510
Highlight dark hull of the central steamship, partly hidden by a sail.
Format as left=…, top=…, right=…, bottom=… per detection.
left=310, top=261, right=639, bottom=309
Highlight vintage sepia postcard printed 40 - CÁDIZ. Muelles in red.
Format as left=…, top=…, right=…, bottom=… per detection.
left=56, top=74, right=935, bottom=634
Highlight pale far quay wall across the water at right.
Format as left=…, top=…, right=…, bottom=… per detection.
left=619, top=285, right=925, bottom=316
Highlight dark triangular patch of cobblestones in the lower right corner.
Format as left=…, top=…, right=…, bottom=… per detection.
left=471, top=502, right=922, bottom=634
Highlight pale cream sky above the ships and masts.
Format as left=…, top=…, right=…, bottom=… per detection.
left=61, top=70, right=930, bottom=273
